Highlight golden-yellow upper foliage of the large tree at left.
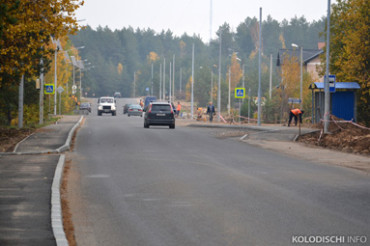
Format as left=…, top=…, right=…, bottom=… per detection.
left=0, top=0, right=83, bottom=85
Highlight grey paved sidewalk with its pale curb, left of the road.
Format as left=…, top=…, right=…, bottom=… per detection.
left=0, top=115, right=82, bottom=246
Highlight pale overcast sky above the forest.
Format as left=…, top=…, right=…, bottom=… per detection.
left=77, top=0, right=335, bottom=41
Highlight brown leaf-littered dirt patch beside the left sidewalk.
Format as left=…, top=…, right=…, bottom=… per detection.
left=0, top=127, right=36, bottom=152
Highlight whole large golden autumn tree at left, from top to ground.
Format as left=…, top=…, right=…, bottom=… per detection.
left=0, top=0, right=83, bottom=123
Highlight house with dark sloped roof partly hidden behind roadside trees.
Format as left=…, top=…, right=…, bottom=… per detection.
left=276, top=43, right=325, bottom=82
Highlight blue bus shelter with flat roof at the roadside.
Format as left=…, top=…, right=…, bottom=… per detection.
left=309, top=82, right=361, bottom=123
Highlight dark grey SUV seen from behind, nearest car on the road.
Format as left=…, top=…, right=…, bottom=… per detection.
left=144, top=102, right=175, bottom=129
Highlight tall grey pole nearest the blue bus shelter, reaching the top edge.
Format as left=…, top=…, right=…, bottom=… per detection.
left=324, top=0, right=330, bottom=133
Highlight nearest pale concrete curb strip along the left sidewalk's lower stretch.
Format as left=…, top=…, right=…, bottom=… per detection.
left=51, top=154, right=69, bottom=246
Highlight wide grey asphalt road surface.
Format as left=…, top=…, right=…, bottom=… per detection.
left=71, top=99, right=370, bottom=246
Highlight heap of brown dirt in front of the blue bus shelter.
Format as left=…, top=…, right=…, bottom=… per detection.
left=298, top=117, right=370, bottom=155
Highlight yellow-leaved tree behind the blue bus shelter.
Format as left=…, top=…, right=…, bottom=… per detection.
left=330, top=0, right=370, bottom=125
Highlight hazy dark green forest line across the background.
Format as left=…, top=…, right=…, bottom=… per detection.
left=71, top=16, right=325, bottom=108
